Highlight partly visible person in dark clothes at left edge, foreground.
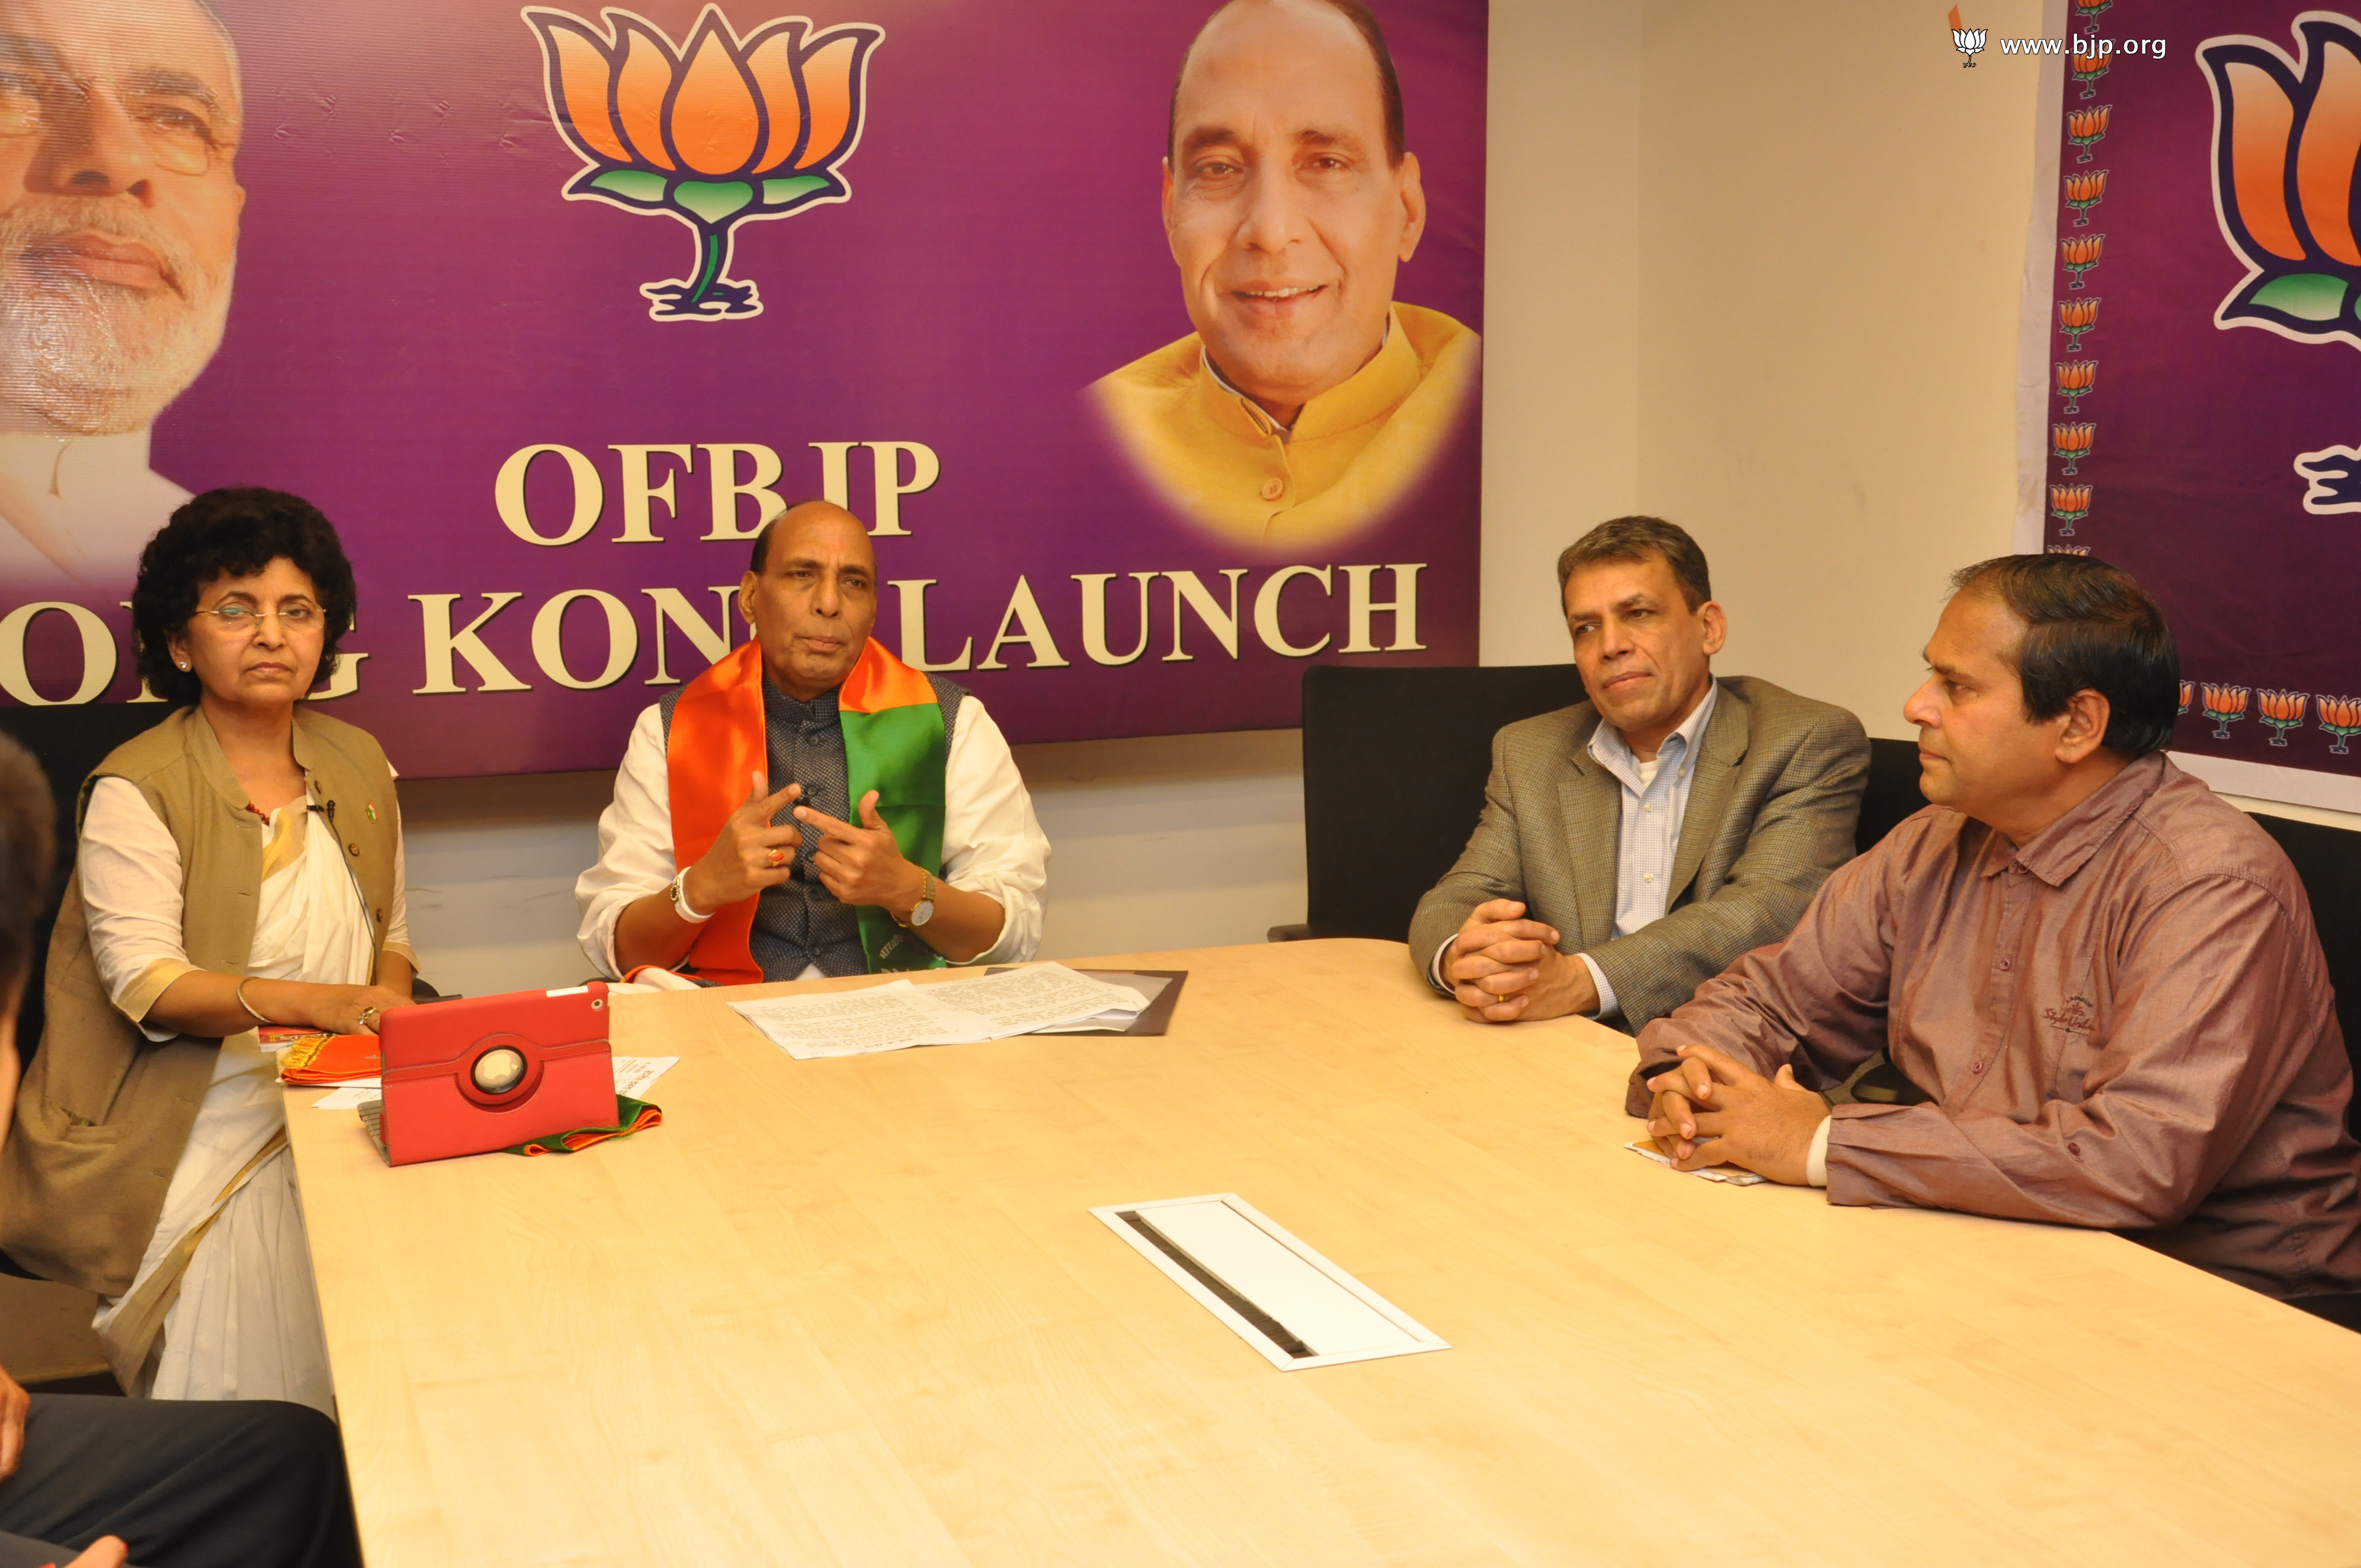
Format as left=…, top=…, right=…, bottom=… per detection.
left=0, top=739, right=361, bottom=1568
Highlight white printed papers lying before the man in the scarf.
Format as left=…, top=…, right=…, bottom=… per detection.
left=730, top=963, right=1147, bottom=1060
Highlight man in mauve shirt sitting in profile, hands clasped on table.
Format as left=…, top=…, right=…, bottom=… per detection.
left=1629, top=555, right=2361, bottom=1327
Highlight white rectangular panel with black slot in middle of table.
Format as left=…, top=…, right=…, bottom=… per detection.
left=1091, top=1193, right=1450, bottom=1372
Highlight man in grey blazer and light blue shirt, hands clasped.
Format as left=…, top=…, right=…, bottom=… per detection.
left=1410, top=517, right=1870, bottom=1032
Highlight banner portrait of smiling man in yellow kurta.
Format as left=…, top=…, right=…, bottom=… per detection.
left=1091, top=0, right=1481, bottom=548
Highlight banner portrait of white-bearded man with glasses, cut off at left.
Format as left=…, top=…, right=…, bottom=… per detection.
left=0, top=0, right=246, bottom=588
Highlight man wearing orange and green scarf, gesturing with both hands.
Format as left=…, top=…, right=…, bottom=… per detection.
left=574, top=500, right=1048, bottom=985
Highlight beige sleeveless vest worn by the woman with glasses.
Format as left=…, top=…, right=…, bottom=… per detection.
left=0, top=706, right=399, bottom=1297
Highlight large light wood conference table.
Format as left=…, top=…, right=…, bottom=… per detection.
left=288, top=942, right=2361, bottom=1568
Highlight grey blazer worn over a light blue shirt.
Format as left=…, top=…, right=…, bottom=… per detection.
left=1410, top=676, right=1870, bottom=1032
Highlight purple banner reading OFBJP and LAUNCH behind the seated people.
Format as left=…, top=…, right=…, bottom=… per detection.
left=0, top=0, right=1482, bottom=777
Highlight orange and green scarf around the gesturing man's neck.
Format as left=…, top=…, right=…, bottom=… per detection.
left=663, top=638, right=949, bottom=985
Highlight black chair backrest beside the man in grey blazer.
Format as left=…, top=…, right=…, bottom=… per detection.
left=1303, top=663, right=1584, bottom=942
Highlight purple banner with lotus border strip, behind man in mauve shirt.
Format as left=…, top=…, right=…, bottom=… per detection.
left=2042, top=0, right=2361, bottom=805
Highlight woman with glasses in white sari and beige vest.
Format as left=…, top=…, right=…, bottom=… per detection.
left=0, top=489, right=413, bottom=1414
